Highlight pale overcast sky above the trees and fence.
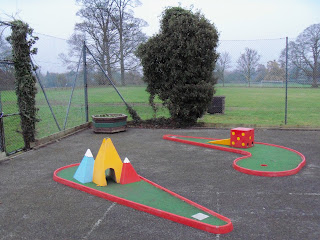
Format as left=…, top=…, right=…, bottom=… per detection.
left=0, top=0, right=320, bottom=40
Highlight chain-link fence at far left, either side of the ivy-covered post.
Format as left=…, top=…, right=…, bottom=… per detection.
left=0, top=26, right=86, bottom=154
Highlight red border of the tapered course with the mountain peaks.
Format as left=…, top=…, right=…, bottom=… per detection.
left=53, top=163, right=233, bottom=234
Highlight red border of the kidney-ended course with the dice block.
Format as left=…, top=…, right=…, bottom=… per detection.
left=163, top=134, right=306, bottom=177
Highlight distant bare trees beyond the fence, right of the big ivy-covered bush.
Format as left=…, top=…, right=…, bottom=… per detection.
left=215, top=24, right=320, bottom=88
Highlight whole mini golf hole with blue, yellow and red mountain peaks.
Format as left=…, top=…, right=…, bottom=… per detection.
left=53, top=138, right=233, bottom=233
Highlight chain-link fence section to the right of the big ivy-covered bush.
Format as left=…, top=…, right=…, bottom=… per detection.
left=203, top=38, right=320, bottom=127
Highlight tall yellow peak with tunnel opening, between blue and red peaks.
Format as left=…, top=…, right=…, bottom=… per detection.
left=92, top=138, right=123, bottom=186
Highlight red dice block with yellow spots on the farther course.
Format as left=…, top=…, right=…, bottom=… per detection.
left=230, top=127, right=254, bottom=148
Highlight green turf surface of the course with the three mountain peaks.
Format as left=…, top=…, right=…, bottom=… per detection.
left=58, top=166, right=227, bottom=226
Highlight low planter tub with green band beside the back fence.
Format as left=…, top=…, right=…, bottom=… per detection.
left=92, top=113, right=127, bottom=133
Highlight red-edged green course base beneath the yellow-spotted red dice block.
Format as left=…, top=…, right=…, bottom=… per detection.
left=163, top=135, right=305, bottom=177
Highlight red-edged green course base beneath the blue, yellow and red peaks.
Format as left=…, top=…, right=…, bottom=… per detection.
left=53, top=163, right=233, bottom=234
